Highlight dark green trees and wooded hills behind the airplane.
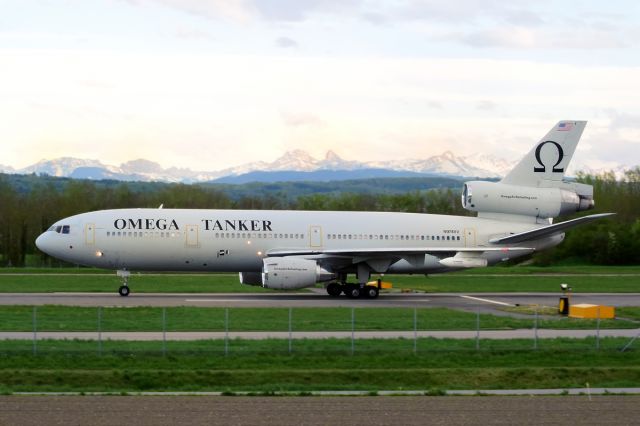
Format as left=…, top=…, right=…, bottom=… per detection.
left=0, top=168, right=640, bottom=266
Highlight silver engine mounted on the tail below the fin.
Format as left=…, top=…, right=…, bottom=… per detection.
left=462, top=181, right=594, bottom=219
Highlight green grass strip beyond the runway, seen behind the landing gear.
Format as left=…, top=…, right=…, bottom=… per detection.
left=0, top=266, right=640, bottom=293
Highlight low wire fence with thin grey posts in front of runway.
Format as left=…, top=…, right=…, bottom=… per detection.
left=0, top=306, right=640, bottom=356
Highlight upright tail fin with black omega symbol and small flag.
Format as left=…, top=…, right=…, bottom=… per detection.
left=501, top=120, right=587, bottom=186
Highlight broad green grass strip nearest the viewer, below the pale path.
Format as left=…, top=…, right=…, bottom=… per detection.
left=0, top=338, right=640, bottom=393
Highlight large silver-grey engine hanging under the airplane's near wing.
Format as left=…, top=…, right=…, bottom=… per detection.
left=262, top=257, right=336, bottom=290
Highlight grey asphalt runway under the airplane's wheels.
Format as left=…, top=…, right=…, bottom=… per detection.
left=0, top=289, right=640, bottom=313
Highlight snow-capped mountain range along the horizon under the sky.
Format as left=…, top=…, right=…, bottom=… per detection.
left=0, top=150, right=625, bottom=183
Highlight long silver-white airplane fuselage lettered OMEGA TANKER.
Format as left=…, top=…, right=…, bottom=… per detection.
left=37, top=209, right=563, bottom=273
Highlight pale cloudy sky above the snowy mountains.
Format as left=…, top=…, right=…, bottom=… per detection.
left=0, top=0, right=640, bottom=171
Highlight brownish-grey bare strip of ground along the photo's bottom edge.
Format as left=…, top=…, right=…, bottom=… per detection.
left=0, top=395, right=640, bottom=426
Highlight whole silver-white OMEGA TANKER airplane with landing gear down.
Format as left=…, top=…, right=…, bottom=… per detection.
left=36, top=121, right=611, bottom=298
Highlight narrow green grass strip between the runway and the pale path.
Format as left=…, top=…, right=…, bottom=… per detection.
left=0, top=306, right=640, bottom=332
